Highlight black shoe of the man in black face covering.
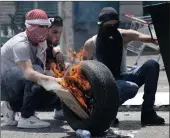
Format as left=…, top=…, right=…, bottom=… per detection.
left=141, top=110, right=165, bottom=126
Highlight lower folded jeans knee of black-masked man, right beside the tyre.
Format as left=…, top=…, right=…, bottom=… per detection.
left=116, top=80, right=139, bottom=105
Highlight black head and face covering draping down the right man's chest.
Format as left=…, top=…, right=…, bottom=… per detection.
left=96, top=7, right=123, bottom=79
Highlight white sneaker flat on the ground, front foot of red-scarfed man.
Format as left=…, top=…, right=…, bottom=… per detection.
left=17, top=116, right=50, bottom=128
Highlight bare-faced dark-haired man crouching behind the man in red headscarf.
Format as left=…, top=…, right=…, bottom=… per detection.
left=46, top=16, right=69, bottom=119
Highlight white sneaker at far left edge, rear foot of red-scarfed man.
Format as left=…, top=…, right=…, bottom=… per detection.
left=1, top=101, right=17, bottom=126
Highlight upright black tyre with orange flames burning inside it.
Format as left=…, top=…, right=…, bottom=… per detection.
left=50, top=60, right=119, bottom=135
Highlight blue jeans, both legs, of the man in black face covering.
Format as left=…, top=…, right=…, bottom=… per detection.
left=117, top=60, right=159, bottom=110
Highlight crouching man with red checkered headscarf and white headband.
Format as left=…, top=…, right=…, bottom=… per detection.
left=1, top=9, right=65, bottom=128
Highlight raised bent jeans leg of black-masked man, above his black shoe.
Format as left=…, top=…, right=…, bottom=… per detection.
left=124, top=60, right=159, bottom=110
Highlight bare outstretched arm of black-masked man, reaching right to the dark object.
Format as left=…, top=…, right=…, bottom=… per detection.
left=121, top=29, right=158, bottom=45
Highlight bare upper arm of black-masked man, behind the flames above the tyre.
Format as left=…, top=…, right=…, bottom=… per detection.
left=83, top=38, right=94, bottom=60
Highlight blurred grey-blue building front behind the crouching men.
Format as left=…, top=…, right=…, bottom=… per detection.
left=0, top=1, right=160, bottom=50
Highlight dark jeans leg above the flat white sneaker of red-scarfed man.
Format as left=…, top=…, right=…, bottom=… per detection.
left=21, top=65, right=61, bottom=118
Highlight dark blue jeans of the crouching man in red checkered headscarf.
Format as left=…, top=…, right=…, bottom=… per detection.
left=1, top=65, right=61, bottom=118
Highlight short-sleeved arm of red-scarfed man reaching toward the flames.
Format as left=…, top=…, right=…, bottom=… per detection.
left=13, top=42, right=60, bottom=89
